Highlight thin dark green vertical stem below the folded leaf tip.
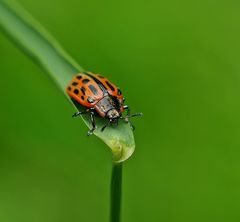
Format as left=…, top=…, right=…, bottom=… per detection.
left=110, top=163, right=122, bottom=222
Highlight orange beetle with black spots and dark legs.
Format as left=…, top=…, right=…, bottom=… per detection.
left=66, top=72, right=142, bottom=136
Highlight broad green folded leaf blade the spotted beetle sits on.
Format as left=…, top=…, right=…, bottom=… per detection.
left=0, top=0, right=135, bottom=162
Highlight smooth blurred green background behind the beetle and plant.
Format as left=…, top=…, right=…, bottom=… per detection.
left=0, top=0, right=240, bottom=222
